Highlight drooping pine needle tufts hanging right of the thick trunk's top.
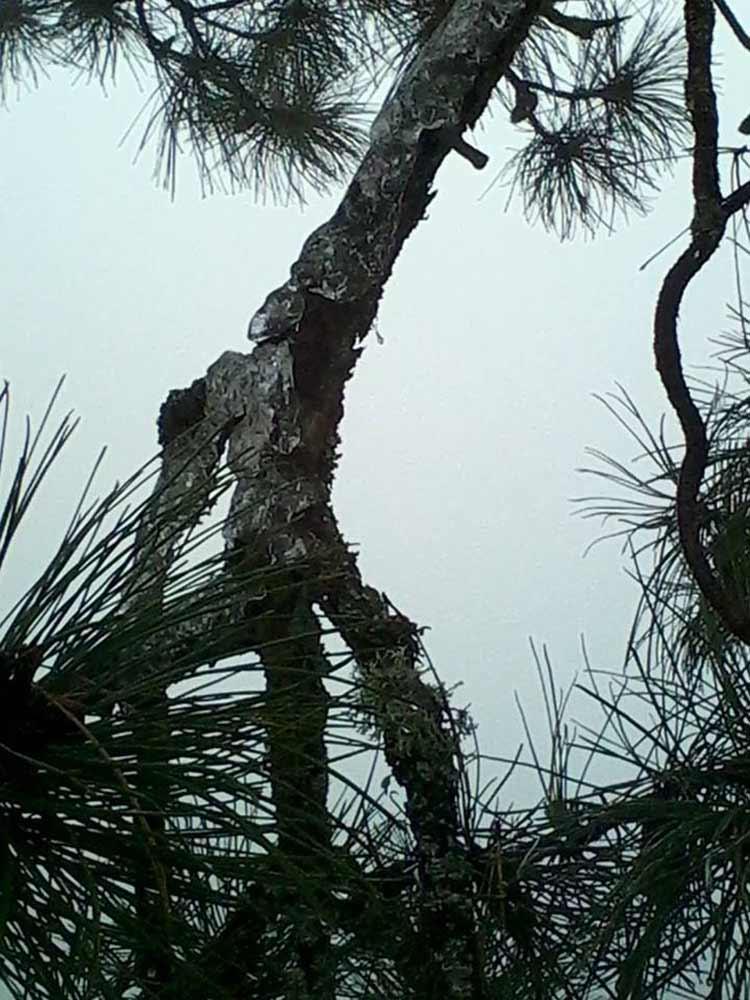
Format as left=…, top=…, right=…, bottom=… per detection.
left=503, top=2, right=687, bottom=237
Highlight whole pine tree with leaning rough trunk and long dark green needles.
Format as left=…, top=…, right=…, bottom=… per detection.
left=0, top=0, right=750, bottom=1000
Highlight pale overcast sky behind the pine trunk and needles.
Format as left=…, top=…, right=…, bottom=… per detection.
left=0, top=13, right=747, bottom=812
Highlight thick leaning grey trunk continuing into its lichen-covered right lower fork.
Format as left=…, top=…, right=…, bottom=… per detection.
left=141, top=0, right=541, bottom=1000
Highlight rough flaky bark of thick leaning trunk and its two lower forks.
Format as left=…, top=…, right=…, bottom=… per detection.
left=142, top=0, right=543, bottom=998
